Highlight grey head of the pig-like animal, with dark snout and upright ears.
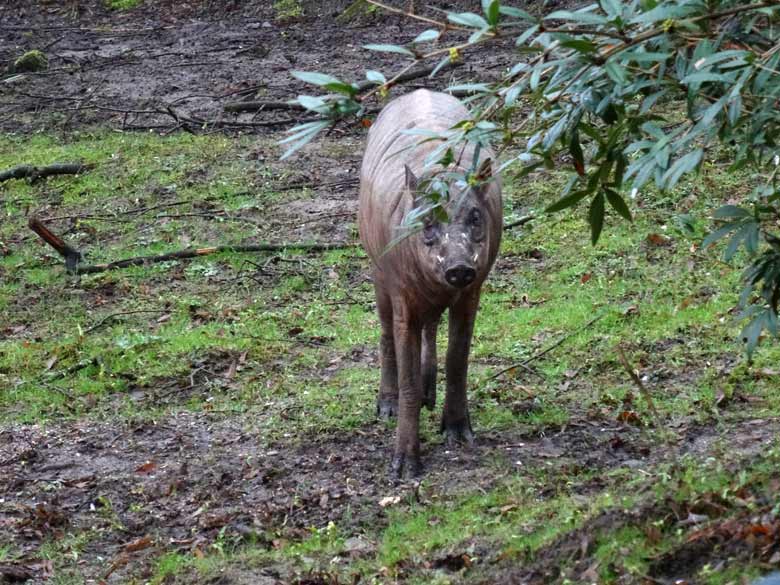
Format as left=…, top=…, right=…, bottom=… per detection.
left=406, top=159, right=497, bottom=289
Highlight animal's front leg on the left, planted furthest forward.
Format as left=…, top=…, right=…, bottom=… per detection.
left=390, top=301, right=422, bottom=479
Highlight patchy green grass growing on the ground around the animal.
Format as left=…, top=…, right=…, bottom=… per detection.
left=0, top=131, right=780, bottom=584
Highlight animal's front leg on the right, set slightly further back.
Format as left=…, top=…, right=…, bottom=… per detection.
left=441, top=290, right=479, bottom=445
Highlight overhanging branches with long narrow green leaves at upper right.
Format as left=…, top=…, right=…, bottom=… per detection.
left=285, top=0, right=780, bottom=353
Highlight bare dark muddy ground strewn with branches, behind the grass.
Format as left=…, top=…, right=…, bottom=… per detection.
left=0, top=1, right=508, bottom=132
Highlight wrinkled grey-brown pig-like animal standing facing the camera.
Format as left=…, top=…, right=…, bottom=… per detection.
left=358, top=90, right=502, bottom=477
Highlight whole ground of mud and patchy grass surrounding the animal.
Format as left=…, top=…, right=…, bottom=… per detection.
left=0, top=0, right=780, bottom=585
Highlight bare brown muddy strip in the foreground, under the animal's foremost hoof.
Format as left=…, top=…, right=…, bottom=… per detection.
left=0, top=413, right=780, bottom=583
